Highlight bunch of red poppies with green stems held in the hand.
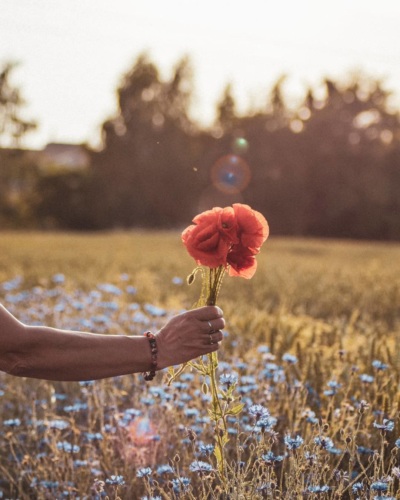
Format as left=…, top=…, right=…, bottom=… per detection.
left=177, top=203, right=269, bottom=475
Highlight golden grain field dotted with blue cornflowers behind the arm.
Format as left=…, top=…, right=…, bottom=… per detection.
left=0, top=231, right=400, bottom=500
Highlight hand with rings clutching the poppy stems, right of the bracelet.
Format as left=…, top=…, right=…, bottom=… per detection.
left=156, top=306, right=225, bottom=370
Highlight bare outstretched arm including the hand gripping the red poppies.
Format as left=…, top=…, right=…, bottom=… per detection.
left=0, top=304, right=225, bottom=381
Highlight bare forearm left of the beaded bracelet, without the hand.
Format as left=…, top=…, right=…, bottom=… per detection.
left=8, top=326, right=150, bottom=381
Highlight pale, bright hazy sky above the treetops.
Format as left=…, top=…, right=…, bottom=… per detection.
left=0, top=0, right=400, bottom=148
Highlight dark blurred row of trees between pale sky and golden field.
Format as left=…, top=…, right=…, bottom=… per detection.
left=0, top=54, right=400, bottom=240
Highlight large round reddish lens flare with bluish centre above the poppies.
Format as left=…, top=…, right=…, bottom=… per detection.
left=211, top=155, right=251, bottom=194
